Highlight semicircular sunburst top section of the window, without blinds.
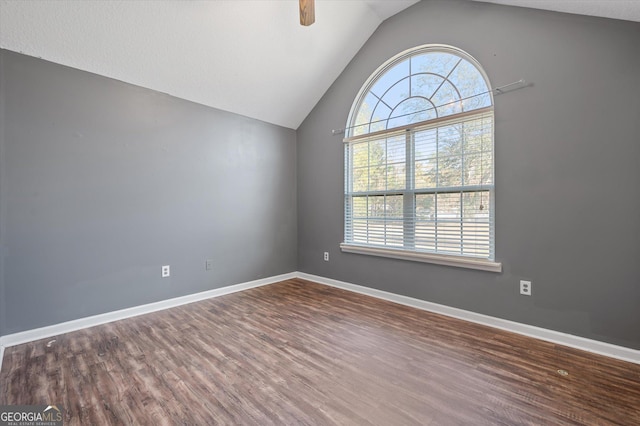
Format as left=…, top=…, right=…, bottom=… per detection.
left=345, top=45, right=493, bottom=137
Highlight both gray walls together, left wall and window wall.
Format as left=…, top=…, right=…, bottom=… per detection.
left=0, top=0, right=640, bottom=349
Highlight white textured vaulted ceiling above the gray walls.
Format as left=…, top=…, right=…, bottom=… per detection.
left=0, top=0, right=640, bottom=129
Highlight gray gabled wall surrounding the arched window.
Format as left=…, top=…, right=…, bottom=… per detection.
left=298, top=0, right=640, bottom=349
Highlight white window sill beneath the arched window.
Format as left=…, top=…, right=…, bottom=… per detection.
left=340, top=243, right=502, bottom=272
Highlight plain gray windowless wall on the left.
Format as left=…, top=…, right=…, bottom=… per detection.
left=0, top=50, right=297, bottom=334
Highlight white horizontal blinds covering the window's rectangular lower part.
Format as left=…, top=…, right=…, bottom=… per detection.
left=345, top=112, right=494, bottom=260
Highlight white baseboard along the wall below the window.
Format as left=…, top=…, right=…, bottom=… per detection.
left=296, top=272, right=640, bottom=364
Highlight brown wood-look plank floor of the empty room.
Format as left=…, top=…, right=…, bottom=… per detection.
left=0, top=279, right=640, bottom=425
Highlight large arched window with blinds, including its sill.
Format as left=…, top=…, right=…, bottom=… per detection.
left=341, top=45, right=501, bottom=271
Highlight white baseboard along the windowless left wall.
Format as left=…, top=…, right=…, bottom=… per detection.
left=0, top=272, right=297, bottom=352
